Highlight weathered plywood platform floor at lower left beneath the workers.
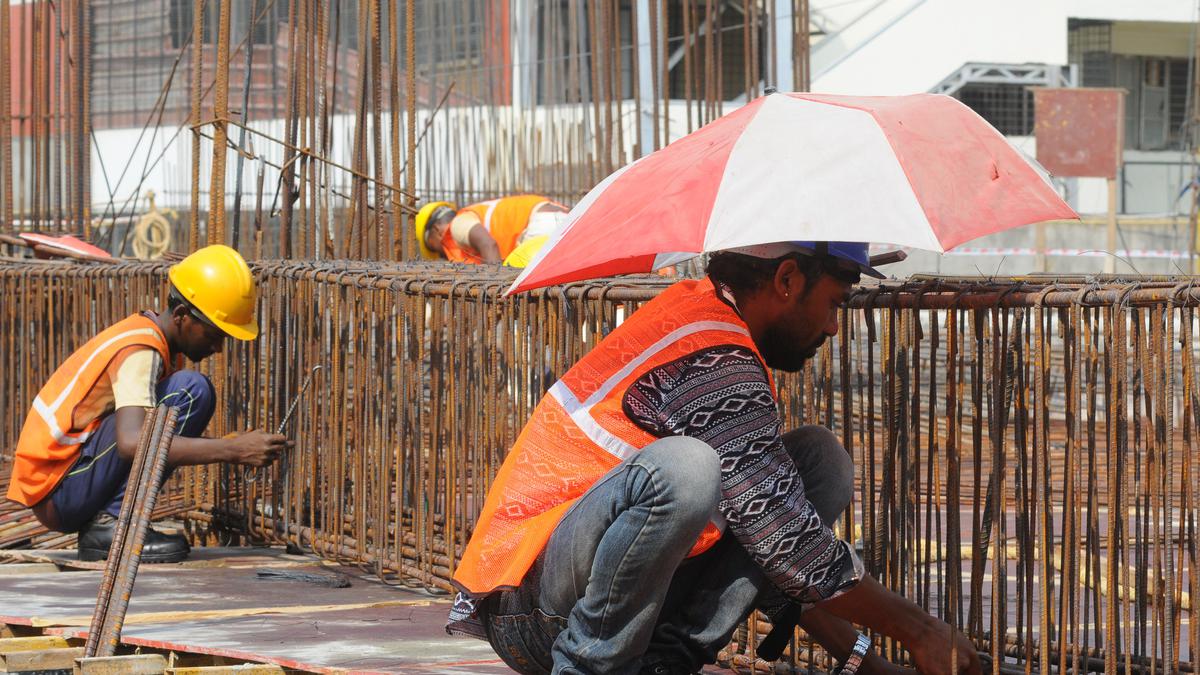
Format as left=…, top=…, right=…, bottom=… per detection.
left=0, top=548, right=727, bottom=675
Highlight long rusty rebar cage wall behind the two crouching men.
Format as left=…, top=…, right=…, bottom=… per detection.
left=0, top=261, right=1200, bottom=673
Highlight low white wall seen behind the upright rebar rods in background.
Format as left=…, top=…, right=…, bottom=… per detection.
left=91, top=100, right=700, bottom=216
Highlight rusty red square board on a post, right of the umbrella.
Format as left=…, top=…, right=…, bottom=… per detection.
left=1033, top=88, right=1124, bottom=178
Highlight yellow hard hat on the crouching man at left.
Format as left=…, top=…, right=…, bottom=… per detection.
left=167, top=244, right=258, bottom=340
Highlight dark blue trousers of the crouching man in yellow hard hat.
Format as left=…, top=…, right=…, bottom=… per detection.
left=48, top=370, right=216, bottom=532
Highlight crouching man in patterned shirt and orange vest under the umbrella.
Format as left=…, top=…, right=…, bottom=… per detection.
left=448, top=241, right=979, bottom=675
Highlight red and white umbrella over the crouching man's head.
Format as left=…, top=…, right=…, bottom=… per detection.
left=509, top=94, right=1079, bottom=293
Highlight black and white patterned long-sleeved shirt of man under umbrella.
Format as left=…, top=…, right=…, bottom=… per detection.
left=446, top=345, right=863, bottom=638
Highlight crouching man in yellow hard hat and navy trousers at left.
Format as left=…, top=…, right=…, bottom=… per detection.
left=8, top=245, right=290, bottom=562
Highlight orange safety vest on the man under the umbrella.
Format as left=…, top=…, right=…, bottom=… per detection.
left=454, top=279, right=774, bottom=597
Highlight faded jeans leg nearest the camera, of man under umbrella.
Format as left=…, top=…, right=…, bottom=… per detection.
left=530, top=436, right=720, bottom=675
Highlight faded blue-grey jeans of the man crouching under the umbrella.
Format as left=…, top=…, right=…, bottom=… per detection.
left=482, top=426, right=853, bottom=675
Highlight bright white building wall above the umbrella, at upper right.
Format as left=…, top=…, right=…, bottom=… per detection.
left=812, top=0, right=1065, bottom=95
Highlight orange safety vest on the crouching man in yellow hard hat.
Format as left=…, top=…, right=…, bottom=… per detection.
left=8, top=315, right=170, bottom=507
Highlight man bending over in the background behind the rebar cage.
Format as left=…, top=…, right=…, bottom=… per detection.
left=414, top=195, right=568, bottom=267
